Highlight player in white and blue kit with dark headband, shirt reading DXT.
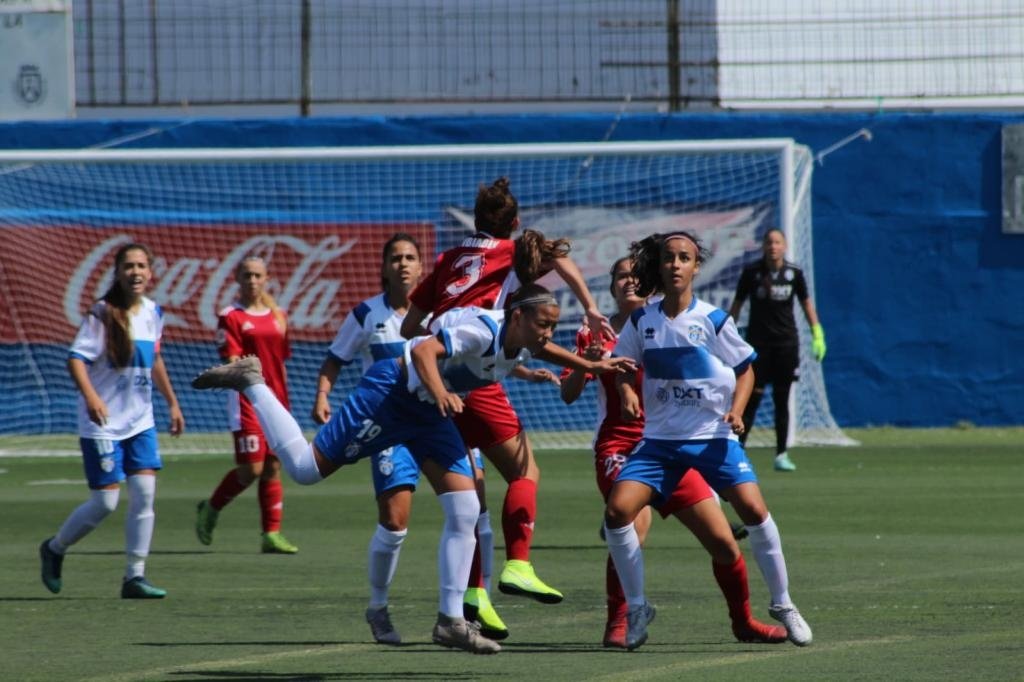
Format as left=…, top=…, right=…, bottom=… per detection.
left=605, top=232, right=811, bottom=649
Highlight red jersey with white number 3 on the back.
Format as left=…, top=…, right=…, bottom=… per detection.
left=410, top=232, right=519, bottom=317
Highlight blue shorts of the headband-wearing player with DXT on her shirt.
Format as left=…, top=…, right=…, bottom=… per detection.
left=615, top=438, right=758, bottom=500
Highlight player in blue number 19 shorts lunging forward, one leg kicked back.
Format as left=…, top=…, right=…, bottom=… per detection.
left=193, top=285, right=629, bottom=653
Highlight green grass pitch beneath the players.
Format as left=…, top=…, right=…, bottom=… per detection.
left=0, top=429, right=1024, bottom=682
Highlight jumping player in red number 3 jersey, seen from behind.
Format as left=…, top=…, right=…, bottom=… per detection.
left=401, top=178, right=611, bottom=604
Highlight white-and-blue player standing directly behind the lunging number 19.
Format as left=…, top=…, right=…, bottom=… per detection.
left=312, top=232, right=508, bottom=644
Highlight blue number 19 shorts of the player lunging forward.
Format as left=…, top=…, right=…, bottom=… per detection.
left=313, top=359, right=473, bottom=483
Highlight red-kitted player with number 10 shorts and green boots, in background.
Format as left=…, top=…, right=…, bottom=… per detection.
left=196, top=256, right=299, bottom=554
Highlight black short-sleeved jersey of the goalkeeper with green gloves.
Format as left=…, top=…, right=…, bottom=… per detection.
left=736, top=259, right=807, bottom=348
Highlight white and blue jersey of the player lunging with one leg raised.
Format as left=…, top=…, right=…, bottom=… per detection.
left=406, top=306, right=531, bottom=402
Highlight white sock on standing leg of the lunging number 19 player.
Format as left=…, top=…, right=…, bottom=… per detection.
left=437, top=491, right=480, bottom=619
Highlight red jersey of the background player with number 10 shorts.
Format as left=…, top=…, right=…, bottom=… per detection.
left=217, top=301, right=292, bottom=433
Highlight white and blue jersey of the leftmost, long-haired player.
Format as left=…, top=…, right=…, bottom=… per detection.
left=69, top=297, right=164, bottom=440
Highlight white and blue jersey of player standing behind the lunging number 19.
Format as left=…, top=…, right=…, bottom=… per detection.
left=327, top=294, right=406, bottom=372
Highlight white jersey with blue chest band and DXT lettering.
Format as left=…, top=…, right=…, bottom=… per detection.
left=614, top=296, right=757, bottom=440
